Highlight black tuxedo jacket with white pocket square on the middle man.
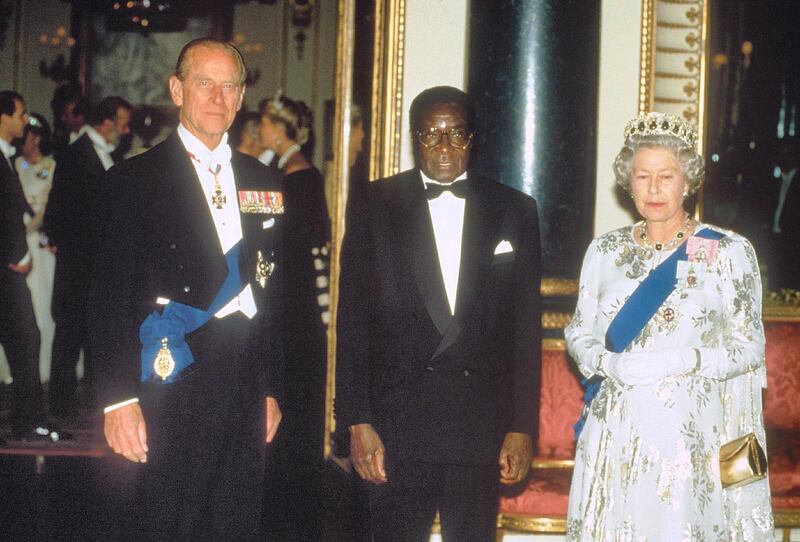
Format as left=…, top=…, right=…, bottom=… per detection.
left=335, top=170, right=541, bottom=465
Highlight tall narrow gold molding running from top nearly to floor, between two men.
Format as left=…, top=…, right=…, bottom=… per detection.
left=323, top=0, right=356, bottom=459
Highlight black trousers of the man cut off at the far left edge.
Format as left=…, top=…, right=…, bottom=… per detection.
left=0, top=269, right=44, bottom=433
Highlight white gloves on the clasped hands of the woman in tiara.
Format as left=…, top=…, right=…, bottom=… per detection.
left=602, top=348, right=700, bottom=386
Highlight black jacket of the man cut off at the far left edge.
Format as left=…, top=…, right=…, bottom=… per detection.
left=0, top=156, right=33, bottom=269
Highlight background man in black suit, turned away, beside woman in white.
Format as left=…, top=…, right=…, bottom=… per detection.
left=44, top=96, right=133, bottom=417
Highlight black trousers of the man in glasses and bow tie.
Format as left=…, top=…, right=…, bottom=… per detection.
left=370, top=461, right=500, bottom=542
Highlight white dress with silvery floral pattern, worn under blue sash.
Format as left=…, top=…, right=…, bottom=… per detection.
left=565, top=224, right=773, bottom=542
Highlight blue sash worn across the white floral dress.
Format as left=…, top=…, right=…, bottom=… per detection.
left=572, top=228, right=725, bottom=439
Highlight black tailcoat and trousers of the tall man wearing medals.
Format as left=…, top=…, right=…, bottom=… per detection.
left=90, top=133, right=283, bottom=539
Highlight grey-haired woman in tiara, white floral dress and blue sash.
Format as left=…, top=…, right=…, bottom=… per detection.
left=565, top=113, right=773, bottom=542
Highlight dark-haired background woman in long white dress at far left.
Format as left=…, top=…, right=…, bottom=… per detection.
left=14, top=113, right=56, bottom=381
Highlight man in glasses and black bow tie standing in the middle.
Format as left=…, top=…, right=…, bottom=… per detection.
left=335, top=87, right=540, bottom=542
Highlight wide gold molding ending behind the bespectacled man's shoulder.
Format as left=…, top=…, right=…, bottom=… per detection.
left=369, top=0, right=406, bottom=180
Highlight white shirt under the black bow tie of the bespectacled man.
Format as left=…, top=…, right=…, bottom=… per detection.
left=420, top=171, right=467, bottom=314
